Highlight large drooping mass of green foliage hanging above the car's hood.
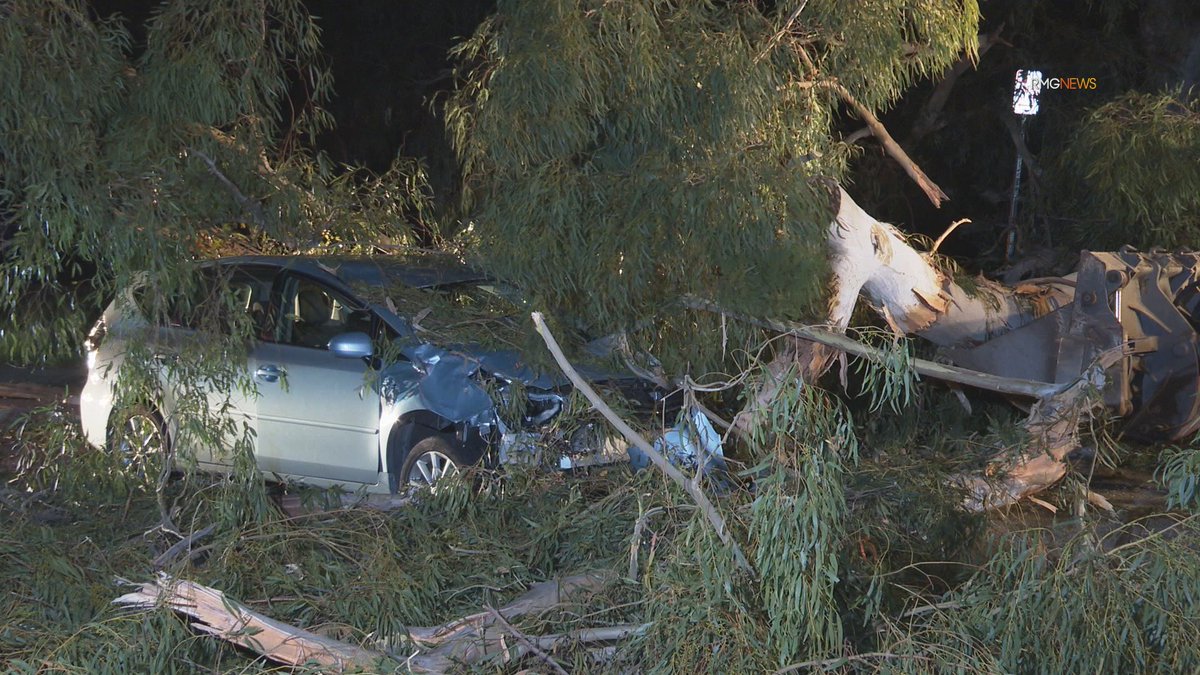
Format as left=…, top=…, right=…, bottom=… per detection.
left=446, top=1, right=979, bottom=370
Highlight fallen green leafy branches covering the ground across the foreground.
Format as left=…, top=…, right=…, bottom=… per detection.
left=9, top=366, right=1200, bottom=673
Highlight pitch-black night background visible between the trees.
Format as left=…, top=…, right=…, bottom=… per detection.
left=92, top=0, right=1200, bottom=261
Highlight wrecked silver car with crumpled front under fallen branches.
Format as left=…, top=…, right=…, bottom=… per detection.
left=80, top=252, right=721, bottom=494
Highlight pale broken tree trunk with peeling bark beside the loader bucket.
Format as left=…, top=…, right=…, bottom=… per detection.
left=734, top=184, right=1094, bottom=508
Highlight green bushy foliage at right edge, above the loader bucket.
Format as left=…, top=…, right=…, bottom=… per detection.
left=1060, top=91, right=1200, bottom=250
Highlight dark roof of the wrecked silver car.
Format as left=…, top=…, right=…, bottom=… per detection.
left=215, top=253, right=490, bottom=288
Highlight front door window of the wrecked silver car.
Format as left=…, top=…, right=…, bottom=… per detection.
left=276, top=276, right=372, bottom=350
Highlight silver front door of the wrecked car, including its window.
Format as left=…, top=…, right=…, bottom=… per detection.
left=252, top=273, right=379, bottom=484
